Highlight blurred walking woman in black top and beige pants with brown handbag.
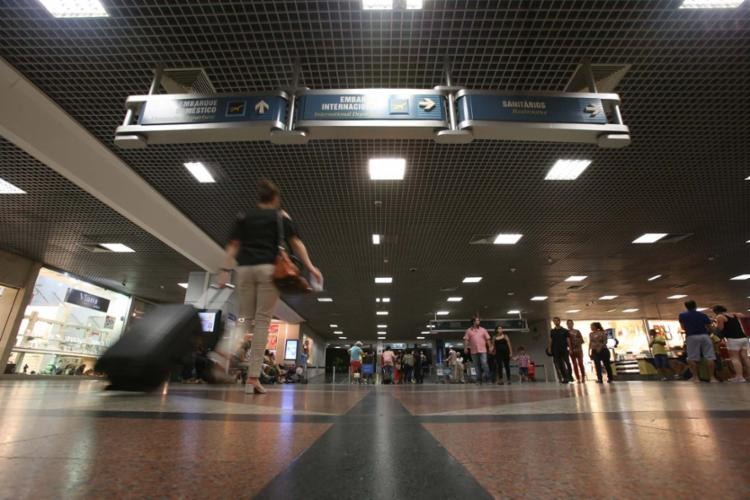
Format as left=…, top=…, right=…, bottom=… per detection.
left=217, top=179, right=323, bottom=394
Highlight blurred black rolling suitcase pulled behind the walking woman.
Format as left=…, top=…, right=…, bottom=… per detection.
left=95, top=304, right=202, bottom=391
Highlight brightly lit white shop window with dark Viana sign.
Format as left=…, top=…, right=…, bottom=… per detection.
left=9, top=269, right=131, bottom=375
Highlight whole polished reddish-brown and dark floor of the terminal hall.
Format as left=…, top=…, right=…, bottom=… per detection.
left=0, top=379, right=750, bottom=500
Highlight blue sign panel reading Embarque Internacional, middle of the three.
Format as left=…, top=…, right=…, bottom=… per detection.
left=297, top=91, right=445, bottom=121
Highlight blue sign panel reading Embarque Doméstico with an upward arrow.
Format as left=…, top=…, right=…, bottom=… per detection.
left=139, top=95, right=286, bottom=125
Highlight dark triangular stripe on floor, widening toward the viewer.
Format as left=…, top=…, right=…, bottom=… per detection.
left=256, top=390, right=491, bottom=500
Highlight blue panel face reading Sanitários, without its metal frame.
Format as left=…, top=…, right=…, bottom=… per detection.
left=456, top=93, right=607, bottom=124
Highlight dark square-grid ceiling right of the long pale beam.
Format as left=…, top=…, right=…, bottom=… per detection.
left=0, top=0, right=750, bottom=339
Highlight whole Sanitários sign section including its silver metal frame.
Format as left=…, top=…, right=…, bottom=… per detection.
left=456, top=90, right=630, bottom=148
